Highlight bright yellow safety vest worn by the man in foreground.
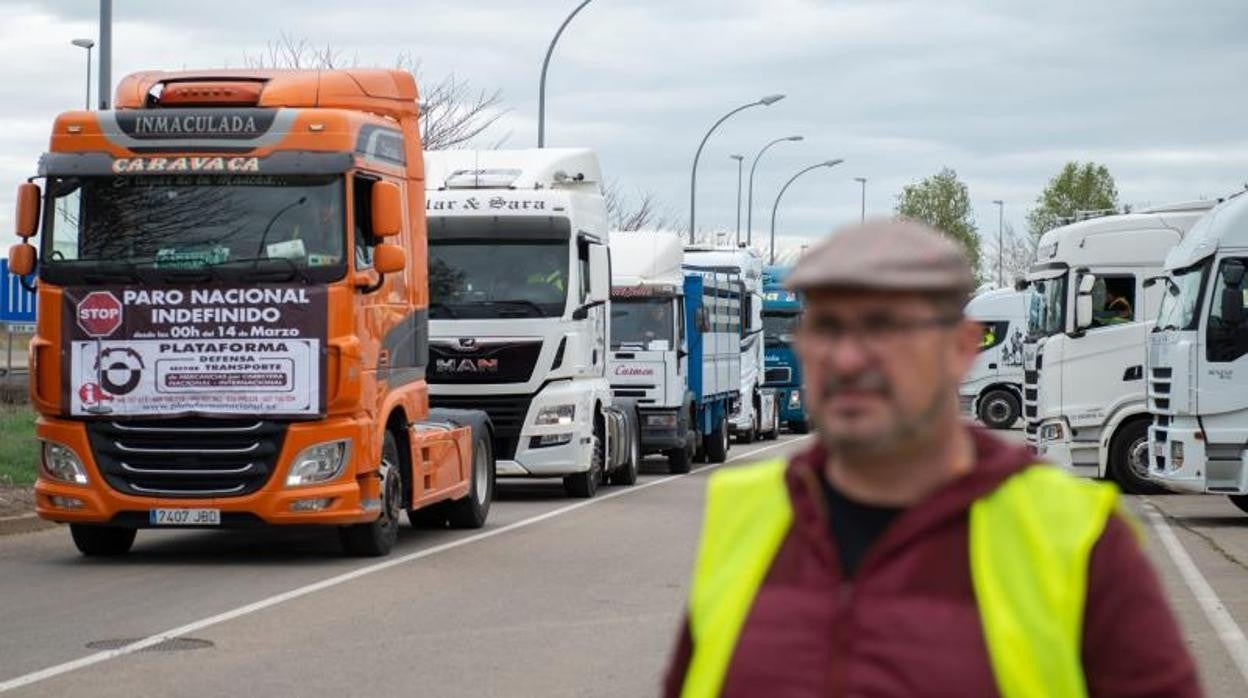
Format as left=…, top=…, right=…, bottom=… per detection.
left=683, top=461, right=1117, bottom=698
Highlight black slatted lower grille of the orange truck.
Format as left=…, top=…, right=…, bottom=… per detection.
left=86, top=417, right=286, bottom=498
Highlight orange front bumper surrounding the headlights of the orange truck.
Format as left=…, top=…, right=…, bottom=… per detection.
left=35, top=417, right=381, bottom=528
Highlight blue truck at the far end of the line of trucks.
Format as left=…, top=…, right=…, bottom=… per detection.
left=763, top=266, right=810, bottom=433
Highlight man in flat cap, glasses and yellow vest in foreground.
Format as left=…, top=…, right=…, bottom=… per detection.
left=665, top=221, right=1199, bottom=698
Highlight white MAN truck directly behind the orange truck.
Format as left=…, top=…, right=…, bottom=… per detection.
left=426, top=149, right=640, bottom=497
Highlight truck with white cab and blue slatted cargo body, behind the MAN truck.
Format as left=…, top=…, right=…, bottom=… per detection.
left=610, top=232, right=741, bottom=473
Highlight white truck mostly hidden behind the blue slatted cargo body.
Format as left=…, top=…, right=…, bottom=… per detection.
left=685, top=245, right=780, bottom=443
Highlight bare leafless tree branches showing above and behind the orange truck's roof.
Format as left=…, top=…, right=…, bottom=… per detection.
left=243, top=34, right=509, bottom=150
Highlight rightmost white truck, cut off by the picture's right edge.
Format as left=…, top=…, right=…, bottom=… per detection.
left=1147, top=194, right=1248, bottom=512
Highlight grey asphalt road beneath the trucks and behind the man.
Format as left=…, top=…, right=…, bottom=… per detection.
left=0, top=437, right=1248, bottom=697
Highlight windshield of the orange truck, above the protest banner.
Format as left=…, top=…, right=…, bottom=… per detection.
left=41, top=175, right=346, bottom=282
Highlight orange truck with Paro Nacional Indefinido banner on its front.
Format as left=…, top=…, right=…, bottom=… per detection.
left=9, top=70, right=494, bottom=556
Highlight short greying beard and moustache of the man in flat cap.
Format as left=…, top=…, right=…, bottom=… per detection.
left=816, top=371, right=952, bottom=457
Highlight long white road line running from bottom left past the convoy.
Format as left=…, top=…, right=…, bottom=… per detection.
left=0, top=435, right=809, bottom=693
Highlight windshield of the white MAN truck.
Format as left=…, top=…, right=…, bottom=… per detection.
left=429, top=216, right=570, bottom=320
